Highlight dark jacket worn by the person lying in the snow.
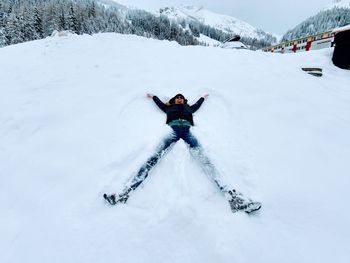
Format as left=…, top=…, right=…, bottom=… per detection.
left=153, top=96, right=204, bottom=125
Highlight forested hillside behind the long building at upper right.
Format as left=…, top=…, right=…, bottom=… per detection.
left=282, top=0, right=350, bottom=42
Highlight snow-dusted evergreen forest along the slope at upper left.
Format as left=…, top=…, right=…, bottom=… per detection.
left=0, top=0, right=274, bottom=49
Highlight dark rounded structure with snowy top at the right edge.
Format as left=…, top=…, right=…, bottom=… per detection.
left=332, top=27, right=350, bottom=69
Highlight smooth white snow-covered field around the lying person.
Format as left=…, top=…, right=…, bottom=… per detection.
left=0, top=34, right=350, bottom=263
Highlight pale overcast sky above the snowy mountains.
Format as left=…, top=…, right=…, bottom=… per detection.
left=115, top=0, right=333, bottom=35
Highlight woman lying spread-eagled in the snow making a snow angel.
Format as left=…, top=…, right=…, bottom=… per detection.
left=103, top=94, right=261, bottom=213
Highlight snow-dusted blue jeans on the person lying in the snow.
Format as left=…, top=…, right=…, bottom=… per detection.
left=124, top=126, right=226, bottom=192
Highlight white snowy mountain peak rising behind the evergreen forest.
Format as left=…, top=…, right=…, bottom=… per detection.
left=160, top=6, right=272, bottom=39
